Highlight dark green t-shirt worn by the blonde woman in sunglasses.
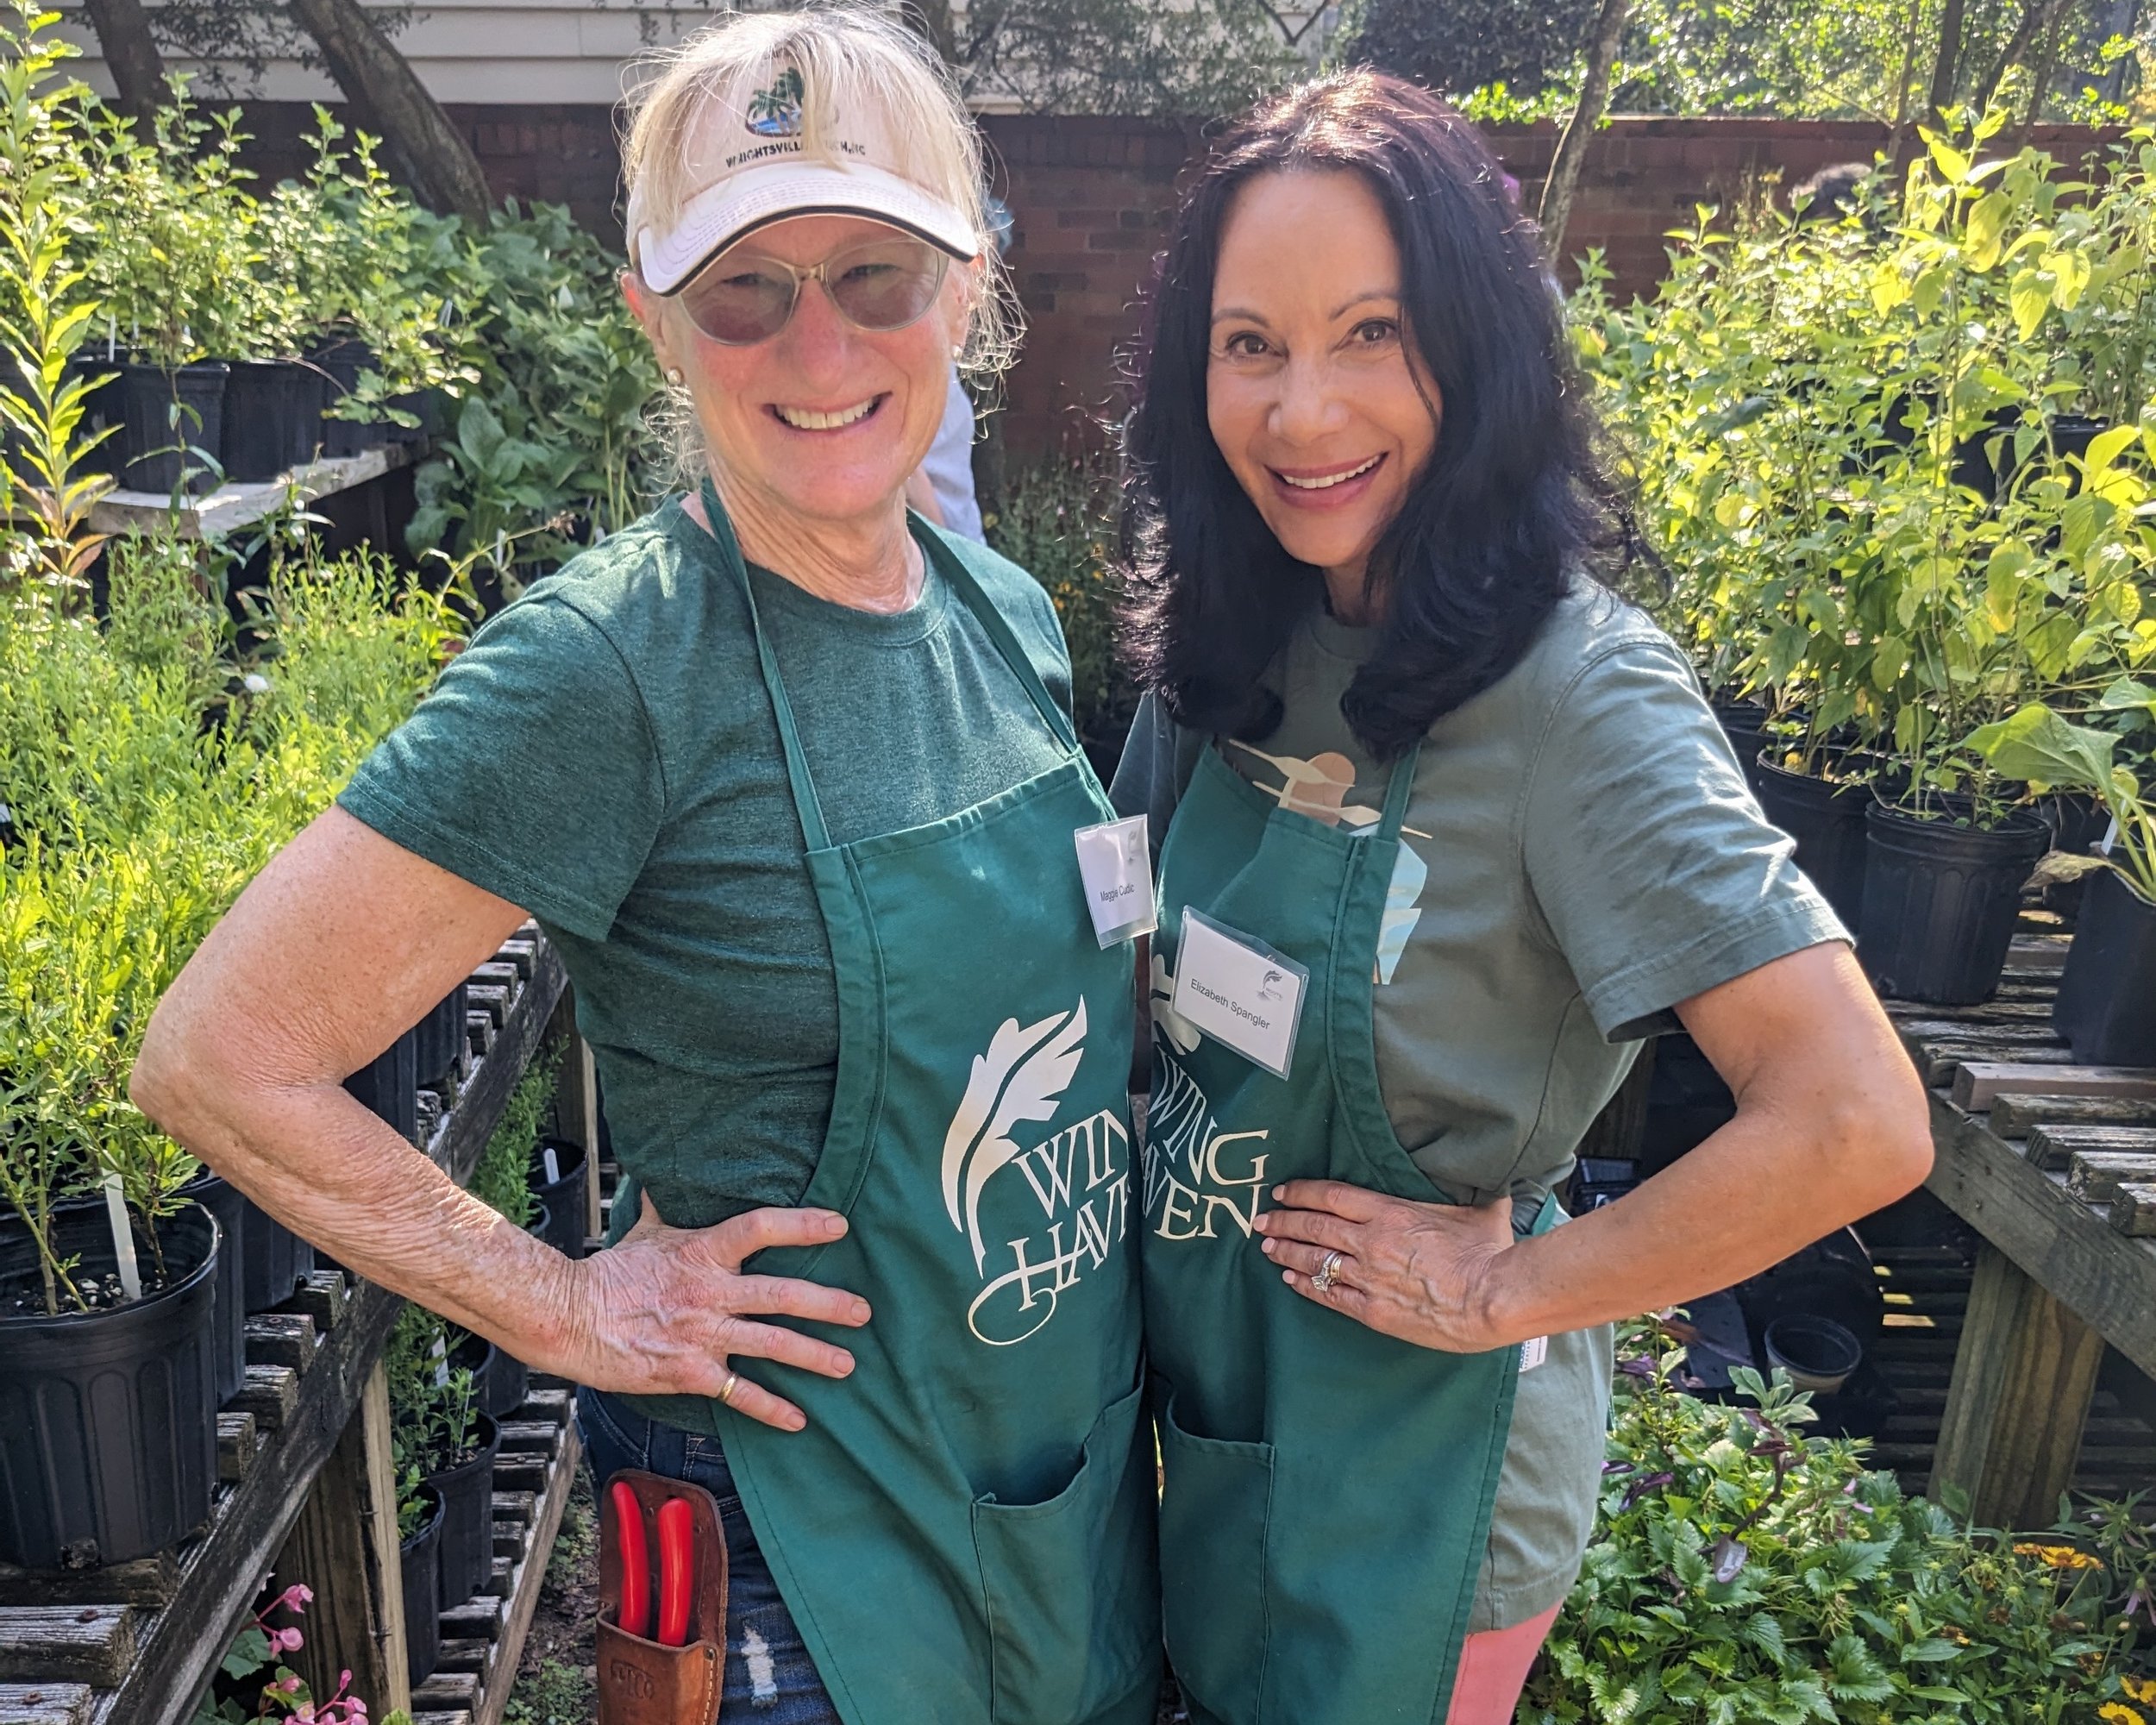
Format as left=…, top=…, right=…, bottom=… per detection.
left=339, top=500, right=1069, bottom=1227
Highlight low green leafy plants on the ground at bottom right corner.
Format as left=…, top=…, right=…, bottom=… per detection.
left=1520, top=1327, right=2150, bottom=1725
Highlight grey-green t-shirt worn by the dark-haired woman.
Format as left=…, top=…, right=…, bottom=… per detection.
left=1115, top=582, right=1848, bottom=1630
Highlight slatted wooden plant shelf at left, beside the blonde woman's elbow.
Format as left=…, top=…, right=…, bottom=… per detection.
left=0, top=932, right=567, bottom=1725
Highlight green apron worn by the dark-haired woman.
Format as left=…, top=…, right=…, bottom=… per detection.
left=1141, top=749, right=1555, bottom=1725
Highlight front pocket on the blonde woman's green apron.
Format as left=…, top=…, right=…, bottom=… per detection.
left=973, top=1387, right=1160, bottom=1725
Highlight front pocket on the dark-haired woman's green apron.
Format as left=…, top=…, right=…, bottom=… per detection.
left=1160, top=1396, right=1272, bottom=1719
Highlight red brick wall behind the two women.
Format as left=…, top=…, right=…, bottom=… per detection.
left=227, top=104, right=2104, bottom=460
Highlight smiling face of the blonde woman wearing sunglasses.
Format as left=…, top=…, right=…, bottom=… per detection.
left=624, top=216, right=970, bottom=526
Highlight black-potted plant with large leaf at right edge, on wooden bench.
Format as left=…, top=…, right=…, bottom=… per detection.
left=1969, top=699, right=2156, bottom=1065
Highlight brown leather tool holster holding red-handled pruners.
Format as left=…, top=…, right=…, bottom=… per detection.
left=599, top=1469, right=727, bottom=1725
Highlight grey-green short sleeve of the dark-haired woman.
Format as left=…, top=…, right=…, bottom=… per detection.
left=1522, top=638, right=1848, bottom=1042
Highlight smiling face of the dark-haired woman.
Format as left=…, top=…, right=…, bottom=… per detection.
left=1206, top=171, right=1440, bottom=612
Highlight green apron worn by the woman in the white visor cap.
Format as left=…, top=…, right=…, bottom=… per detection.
left=703, top=486, right=1160, bottom=1725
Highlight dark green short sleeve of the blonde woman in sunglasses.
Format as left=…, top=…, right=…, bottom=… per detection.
left=339, top=593, right=664, bottom=940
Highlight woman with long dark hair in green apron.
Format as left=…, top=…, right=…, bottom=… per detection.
left=1115, top=73, right=1930, bottom=1725
